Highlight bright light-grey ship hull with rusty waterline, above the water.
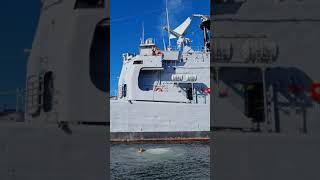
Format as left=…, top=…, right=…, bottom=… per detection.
left=110, top=100, right=210, bottom=142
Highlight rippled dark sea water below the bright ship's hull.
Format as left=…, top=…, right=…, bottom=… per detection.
left=111, top=143, right=210, bottom=180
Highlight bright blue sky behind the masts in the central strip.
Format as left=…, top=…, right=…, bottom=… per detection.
left=110, top=0, right=210, bottom=95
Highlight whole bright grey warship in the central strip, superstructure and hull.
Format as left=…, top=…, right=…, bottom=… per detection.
left=110, top=14, right=211, bottom=141
